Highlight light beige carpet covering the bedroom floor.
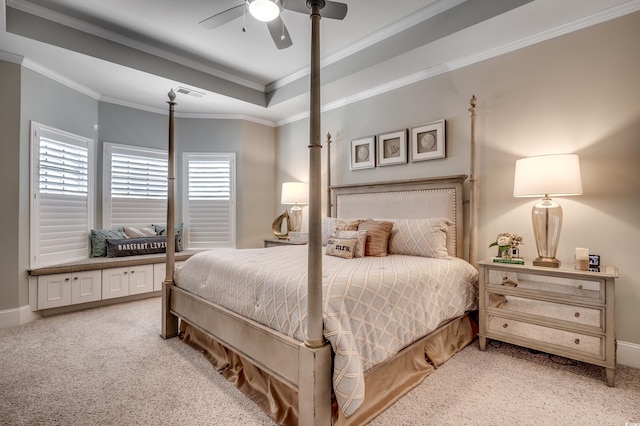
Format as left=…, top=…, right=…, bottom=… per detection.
left=0, top=297, right=640, bottom=426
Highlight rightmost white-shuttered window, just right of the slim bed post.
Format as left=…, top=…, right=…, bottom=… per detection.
left=182, top=153, right=236, bottom=249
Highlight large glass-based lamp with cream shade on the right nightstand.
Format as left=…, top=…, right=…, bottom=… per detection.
left=513, top=154, right=582, bottom=268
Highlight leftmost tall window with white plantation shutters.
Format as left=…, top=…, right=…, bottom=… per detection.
left=30, top=122, right=93, bottom=267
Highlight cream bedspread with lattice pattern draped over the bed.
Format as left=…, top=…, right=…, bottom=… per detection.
left=175, top=246, right=478, bottom=416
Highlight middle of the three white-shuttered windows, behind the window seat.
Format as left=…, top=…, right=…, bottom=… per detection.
left=102, top=142, right=168, bottom=228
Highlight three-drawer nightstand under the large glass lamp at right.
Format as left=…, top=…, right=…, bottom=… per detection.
left=478, top=260, right=618, bottom=386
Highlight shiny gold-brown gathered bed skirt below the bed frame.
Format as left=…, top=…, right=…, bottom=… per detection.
left=180, top=314, right=478, bottom=426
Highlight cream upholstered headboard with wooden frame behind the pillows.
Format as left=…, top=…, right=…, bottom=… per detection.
left=331, top=175, right=467, bottom=257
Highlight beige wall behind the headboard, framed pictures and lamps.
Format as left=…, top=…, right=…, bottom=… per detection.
left=276, top=13, right=640, bottom=344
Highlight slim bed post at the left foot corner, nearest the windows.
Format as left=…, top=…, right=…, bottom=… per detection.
left=161, top=89, right=178, bottom=339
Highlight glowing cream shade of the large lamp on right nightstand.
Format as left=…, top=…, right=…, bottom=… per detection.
left=513, top=154, right=582, bottom=197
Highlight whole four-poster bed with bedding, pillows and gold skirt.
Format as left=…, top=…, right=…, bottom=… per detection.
left=161, top=2, right=478, bottom=425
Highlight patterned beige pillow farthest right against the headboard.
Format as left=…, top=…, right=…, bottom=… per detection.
left=389, top=218, right=453, bottom=259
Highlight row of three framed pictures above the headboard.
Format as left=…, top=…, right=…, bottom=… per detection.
left=351, top=120, right=446, bottom=170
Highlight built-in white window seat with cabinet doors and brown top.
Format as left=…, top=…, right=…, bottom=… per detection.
left=28, top=250, right=198, bottom=315
